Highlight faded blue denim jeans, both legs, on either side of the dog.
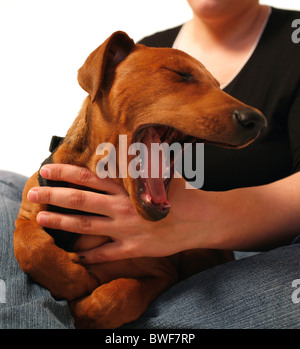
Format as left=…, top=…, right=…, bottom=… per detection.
left=0, top=171, right=300, bottom=329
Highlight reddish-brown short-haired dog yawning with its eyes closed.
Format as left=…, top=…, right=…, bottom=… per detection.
left=14, top=32, right=266, bottom=328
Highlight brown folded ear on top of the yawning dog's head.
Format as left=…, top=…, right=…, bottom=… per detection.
left=78, top=31, right=135, bottom=102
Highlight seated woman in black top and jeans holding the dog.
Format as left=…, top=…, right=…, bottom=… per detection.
left=1, top=0, right=300, bottom=328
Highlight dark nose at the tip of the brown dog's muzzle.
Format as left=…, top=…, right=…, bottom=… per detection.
left=232, top=108, right=267, bottom=133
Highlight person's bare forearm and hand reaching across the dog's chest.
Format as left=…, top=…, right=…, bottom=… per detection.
left=29, top=164, right=300, bottom=263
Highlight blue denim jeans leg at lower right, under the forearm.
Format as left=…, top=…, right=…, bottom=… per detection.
left=128, top=244, right=300, bottom=329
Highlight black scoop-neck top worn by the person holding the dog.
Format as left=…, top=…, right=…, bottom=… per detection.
left=140, top=8, right=300, bottom=190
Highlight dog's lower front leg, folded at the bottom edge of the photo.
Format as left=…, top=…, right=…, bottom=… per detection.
left=70, top=275, right=174, bottom=329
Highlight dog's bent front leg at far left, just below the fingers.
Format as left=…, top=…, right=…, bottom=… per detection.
left=14, top=218, right=99, bottom=301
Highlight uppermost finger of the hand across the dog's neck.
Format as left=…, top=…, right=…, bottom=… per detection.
left=40, top=164, right=123, bottom=194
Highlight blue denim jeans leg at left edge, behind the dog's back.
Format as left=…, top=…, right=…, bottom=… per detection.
left=0, top=171, right=74, bottom=329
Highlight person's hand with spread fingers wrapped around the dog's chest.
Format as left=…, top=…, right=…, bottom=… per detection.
left=28, top=164, right=206, bottom=263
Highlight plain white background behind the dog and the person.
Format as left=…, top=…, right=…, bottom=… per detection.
left=0, top=0, right=300, bottom=176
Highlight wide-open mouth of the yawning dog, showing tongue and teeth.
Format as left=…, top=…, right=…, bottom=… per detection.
left=133, top=125, right=240, bottom=220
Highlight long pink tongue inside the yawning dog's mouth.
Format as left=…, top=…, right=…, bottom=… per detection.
left=142, top=127, right=170, bottom=209
